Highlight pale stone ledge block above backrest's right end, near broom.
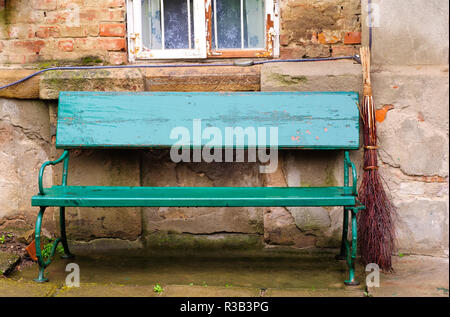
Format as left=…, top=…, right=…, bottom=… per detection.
left=261, top=60, right=363, bottom=91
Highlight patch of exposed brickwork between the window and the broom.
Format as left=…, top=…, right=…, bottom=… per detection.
left=280, top=0, right=361, bottom=58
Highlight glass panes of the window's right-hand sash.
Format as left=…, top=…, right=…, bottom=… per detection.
left=211, top=0, right=265, bottom=49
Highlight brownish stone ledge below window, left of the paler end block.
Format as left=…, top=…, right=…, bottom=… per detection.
left=0, top=65, right=261, bottom=100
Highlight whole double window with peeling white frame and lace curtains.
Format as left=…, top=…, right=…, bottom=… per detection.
left=127, top=0, right=279, bottom=61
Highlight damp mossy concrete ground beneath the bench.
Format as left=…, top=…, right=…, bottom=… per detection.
left=0, top=249, right=449, bottom=297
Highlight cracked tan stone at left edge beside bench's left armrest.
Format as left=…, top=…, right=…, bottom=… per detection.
left=0, top=99, right=52, bottom=229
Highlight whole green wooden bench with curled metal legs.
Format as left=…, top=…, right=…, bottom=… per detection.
left=31, top=92, right=364, bottom=285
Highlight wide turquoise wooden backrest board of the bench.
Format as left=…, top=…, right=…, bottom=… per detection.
left=56, top=92, right=359, bottom=149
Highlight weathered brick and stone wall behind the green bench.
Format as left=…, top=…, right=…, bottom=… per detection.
left=0, top=0, right=449, bottom=255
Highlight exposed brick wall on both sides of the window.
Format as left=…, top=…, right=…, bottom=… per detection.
left=0, top=0, right=361, bottom=64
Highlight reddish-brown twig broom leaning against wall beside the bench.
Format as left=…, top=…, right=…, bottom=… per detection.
left=358, top=47, right=395, bottom=271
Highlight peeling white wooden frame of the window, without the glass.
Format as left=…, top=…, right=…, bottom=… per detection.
left=127, top=0, right=279, bottom=62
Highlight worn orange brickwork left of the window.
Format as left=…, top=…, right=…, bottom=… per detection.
left=0, top=0, right=127, bottom=64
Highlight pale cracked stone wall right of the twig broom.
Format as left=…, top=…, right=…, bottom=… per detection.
left=362, top=0, right=449, bottom=256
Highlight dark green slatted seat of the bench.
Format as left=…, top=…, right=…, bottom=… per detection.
left=31, top=186, right=356, bottom=207
